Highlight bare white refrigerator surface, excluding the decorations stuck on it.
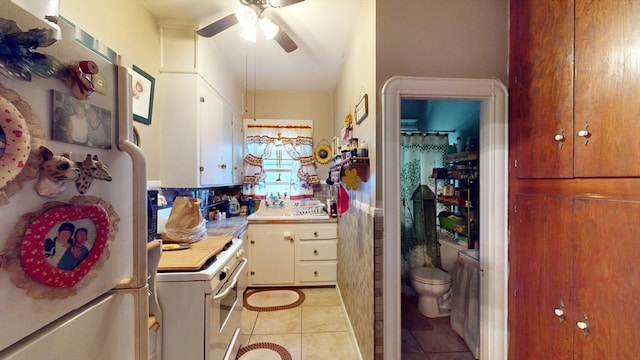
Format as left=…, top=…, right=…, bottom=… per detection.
left=0, top=0, right=148, bottom=359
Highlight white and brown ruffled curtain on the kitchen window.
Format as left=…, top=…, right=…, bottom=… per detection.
left=243, top=120, right=320, bottom=199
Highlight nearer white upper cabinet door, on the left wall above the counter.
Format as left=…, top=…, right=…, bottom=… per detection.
left=199, top=81, right=232, bottom=186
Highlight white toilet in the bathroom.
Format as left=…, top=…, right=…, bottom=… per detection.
left=409, top=238, right=467, bottom=318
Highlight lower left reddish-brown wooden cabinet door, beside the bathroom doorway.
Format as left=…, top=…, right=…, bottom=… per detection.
left=509, top=194, right=573, bottom=360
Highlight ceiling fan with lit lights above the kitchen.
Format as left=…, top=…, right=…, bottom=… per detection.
left=197, top=0, right=304, bottom=53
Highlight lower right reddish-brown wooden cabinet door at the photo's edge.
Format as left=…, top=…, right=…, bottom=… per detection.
left=569, top=199, right=640, bottom=359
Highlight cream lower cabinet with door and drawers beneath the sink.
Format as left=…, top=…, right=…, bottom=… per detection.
left=247, top=223, right=338, bottom=286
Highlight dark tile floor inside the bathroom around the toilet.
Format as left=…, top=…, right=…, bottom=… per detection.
left=402, top=294, right=475, bottom=360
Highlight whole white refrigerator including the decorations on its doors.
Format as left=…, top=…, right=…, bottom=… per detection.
left=0, top=0, right=149, bottom=360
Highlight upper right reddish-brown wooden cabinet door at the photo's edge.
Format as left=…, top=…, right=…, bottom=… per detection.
left=574, top=0, right=640, bottom=177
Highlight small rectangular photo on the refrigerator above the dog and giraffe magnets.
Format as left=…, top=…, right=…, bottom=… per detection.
left=51, top=90, right=112, bottom=149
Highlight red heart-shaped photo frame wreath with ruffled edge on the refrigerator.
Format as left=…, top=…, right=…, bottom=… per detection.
left=4, top=196, right=120, bottom=299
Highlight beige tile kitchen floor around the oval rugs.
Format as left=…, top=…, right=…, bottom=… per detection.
left=240, top=288, right=358, bottom=360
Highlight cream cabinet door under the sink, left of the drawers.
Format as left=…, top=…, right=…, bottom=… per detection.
left=249, top=225, right=295, bottom=285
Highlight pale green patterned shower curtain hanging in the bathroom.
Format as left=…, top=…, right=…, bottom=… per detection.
left=400, top=134, right=449, bottom=278
